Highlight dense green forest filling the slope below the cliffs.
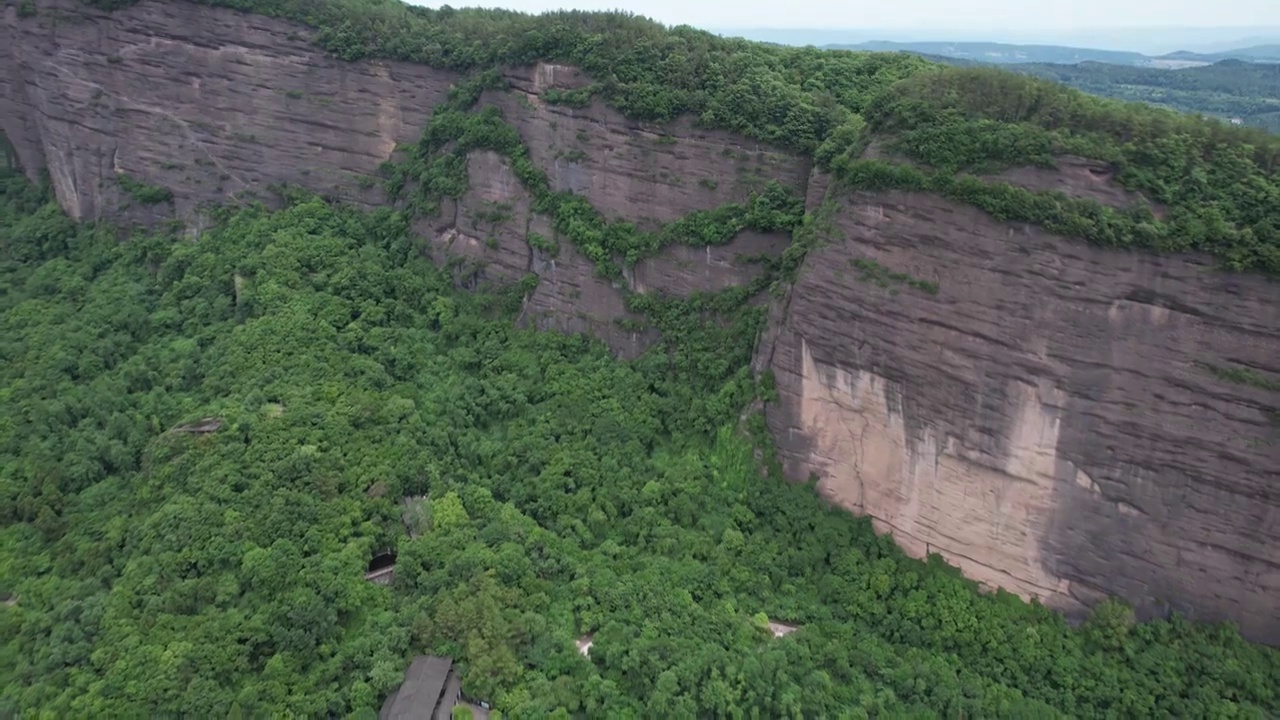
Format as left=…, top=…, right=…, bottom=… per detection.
left=0, top=166, right=1280, bottom=717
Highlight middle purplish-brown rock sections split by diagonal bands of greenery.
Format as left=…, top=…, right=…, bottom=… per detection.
left=420, top=64, right=809, bottom=357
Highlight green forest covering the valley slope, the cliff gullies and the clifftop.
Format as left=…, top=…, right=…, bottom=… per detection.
left=0, top=0, right=1280, bottom=717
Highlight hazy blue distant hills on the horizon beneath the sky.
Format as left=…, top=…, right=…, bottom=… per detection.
left=826, top=40, right=1280, bottom=69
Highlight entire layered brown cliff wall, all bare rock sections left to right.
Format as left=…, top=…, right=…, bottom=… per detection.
left=0, top=0, right=1280, bottom=642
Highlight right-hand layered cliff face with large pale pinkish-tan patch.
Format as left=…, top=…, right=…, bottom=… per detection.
left=758, top=183, right=1280, bottom=642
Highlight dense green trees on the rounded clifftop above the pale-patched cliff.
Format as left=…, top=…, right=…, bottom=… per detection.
left=860, top=68, right=1280, bottom=273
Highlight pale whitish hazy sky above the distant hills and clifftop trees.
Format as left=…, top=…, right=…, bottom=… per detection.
left=411, top=0, right=1280, bottom=35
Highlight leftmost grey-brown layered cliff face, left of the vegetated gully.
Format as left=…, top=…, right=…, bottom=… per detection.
left=0, top=0, right=453, bottom=222
